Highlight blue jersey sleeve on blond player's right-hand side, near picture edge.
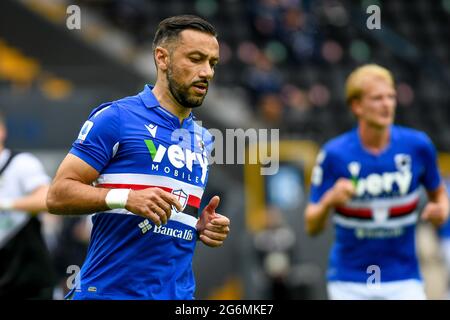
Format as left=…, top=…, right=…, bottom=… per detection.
left=420, top=134, right=441, bottom=191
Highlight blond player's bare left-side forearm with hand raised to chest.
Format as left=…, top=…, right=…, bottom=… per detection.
left=305, top=178, right=355, bottom=235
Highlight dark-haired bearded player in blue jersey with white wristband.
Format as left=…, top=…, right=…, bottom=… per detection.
left=47, top=15, right=230, bottom=299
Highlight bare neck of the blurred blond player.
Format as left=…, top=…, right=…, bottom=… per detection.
left=358, top=123, right=391, bottom=154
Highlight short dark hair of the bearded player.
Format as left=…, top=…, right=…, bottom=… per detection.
left=153, top=15, right=217, bottom=51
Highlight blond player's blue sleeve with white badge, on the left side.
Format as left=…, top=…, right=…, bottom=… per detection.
left=309, top=149, right=336, bottom=203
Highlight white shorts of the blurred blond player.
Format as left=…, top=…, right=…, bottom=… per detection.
left=327, top=279, right=426, bottom=300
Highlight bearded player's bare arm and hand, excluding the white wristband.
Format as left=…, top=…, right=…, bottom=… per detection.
left=47, top=154, right=182, bottom=225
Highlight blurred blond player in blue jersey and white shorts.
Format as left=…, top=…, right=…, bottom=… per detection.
left=305, top=64, right=449, bottom=299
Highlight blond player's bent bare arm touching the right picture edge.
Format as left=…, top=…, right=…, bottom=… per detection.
left=422, top=183, right=450, bottom=227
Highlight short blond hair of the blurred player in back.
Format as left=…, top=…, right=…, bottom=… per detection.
left=345, top=64, right=394, bottom=106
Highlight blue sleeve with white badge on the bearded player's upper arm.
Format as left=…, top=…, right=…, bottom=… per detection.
left=70, top=103, right=120, bottom=172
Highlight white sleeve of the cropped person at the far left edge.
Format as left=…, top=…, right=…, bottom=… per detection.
left=13, top=153, right=50, bottom=194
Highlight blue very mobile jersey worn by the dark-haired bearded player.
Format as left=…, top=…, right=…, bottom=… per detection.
left=70, top=86, right=212, bottom=299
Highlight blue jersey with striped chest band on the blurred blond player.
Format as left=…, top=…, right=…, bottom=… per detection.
left=310, top=126, right=440, bottom=282
